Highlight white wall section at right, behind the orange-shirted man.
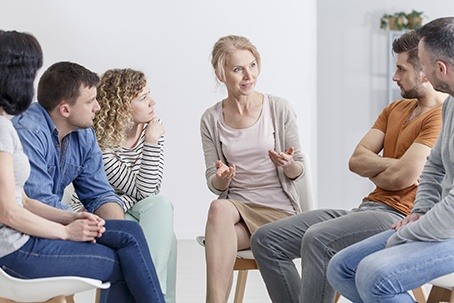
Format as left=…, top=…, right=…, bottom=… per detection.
left=317, top=0, right=454, bottom=213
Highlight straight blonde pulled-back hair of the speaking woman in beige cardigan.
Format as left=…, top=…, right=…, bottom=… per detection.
left=211, top=35, right=261, bottom=82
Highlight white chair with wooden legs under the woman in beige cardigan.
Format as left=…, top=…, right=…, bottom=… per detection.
left=197, top=153, right=315, bottom=303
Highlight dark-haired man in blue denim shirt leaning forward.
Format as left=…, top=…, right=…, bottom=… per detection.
left=12, top=62, right=124, bottom=219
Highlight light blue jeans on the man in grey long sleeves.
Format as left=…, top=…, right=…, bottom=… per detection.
left=327, top=230, right=454, bottom=303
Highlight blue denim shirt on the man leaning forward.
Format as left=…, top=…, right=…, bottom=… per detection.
left=12, top=102, right=123, bottom=212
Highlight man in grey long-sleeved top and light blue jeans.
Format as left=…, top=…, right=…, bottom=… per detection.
left=327, top=17, right=454, bottom=302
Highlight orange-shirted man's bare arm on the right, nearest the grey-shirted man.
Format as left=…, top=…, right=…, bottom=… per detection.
left=370, top=143, right=430, bottom=190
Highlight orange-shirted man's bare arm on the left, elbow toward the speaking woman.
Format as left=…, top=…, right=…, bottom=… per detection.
left=348, top=129, right=397, bottom=178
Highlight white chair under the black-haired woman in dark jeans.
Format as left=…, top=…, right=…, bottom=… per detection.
left=0, top=268, right=110, bottom=303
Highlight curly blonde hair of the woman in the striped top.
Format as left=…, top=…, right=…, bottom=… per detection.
left=94, top=68, right=147, bottom=150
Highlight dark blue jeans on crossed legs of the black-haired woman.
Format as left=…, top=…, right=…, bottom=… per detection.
left=0, top=220, right=164, bottom=303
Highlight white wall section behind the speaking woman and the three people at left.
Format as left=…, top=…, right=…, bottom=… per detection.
left=0, top=0, right=317, bottom=238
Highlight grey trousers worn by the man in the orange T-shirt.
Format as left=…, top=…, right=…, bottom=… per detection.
left=251, top=201, right=404, bottom=303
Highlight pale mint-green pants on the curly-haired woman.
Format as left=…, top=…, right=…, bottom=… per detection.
left=125, top=195, right=177, bottom=303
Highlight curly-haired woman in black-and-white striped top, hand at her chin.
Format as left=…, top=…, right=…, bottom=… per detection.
left=76, top=69, right=176, bottom=302
